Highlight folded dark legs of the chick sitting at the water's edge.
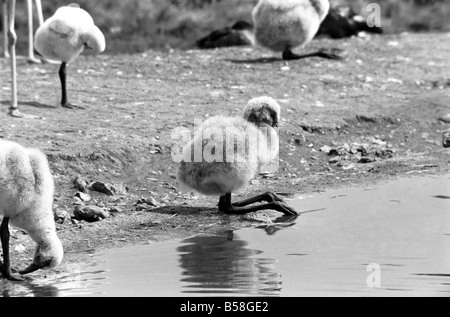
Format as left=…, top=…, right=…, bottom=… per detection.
left=219, top=193, right=298, bottom=215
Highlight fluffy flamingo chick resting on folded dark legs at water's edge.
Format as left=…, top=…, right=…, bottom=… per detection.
left=177, top=96, right=298, bottom=215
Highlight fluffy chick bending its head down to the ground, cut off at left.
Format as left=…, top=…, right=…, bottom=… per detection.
left=0, top=140, right=64, bottom=280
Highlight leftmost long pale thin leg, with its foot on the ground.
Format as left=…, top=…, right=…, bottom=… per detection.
left=8, top=0, right=39, bottom=119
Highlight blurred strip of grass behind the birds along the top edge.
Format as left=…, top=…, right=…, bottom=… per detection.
left=2, top=0, right=450, bottom=54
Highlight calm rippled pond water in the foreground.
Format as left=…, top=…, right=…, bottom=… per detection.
left=0, top=175, right=450, bottom=296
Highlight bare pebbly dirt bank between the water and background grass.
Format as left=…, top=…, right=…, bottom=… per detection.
left=0, top=34, right=450, bottom=270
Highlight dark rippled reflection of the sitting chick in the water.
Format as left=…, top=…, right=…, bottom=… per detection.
left=177, top=231, right=281, bottom=296
